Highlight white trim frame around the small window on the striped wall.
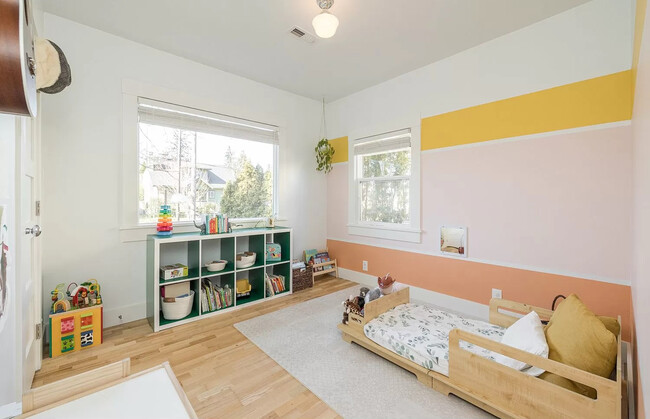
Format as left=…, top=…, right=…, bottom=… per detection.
left=347, top=120, right=422, bottom=243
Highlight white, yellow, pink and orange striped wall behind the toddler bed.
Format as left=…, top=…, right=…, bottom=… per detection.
left=327, top=0, right=638, bottom=337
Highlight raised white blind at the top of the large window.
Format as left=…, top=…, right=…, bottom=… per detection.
left=138, top=98, right=279, bottom=144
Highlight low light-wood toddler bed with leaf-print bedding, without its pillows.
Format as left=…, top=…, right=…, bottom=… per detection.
left=338, top=288, right=626, bottom=419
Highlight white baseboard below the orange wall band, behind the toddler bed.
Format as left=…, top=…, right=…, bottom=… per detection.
left=339, top=268, right=490, bottom=321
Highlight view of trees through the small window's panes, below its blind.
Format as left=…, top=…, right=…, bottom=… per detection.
left=358, top=150, right=411, bottom=224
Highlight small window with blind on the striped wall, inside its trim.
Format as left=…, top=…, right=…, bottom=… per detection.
left=351, top=129, right=419, bottom=241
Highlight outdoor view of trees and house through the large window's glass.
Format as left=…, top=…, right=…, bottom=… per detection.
left=138, top=123, right=276, bottom=224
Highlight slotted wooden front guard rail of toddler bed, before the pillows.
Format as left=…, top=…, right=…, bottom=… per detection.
left=449, top=328, right=622, bottom=419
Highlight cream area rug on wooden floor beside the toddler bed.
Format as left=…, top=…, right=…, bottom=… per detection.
left=235, top=287, right=493, bottom=419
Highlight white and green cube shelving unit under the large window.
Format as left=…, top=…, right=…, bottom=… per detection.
left=147, top=227, right=293, bottom=332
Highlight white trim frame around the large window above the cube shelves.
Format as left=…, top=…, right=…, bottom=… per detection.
left=119, top=79, right=287, bottom=242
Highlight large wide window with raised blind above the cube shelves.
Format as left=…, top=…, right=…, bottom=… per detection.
left=138, top=99, right=278, bottom=224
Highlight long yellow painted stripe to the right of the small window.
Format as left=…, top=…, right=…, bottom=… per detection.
left=421, top=70, right=632, bottom=150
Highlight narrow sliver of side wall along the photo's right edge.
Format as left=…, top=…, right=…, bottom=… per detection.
left=632, top=0, right=650, bottom=419
